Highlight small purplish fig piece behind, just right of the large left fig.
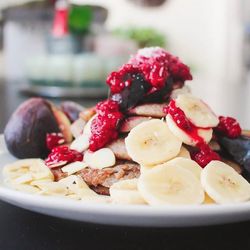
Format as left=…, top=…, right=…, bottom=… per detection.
left=60, top=101, right=85, bottom=122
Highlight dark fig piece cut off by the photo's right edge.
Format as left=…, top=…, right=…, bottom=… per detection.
left=218, top=136, right=250, bottom=174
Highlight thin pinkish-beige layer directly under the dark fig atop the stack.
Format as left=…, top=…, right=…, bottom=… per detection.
left=128, top=103, right=167, bottom=118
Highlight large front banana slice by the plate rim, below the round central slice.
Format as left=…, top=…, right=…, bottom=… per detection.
left=138, top=162, right=204, bottom=205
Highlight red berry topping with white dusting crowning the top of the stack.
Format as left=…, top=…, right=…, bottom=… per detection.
left=107, top=47, right=192, bottom=94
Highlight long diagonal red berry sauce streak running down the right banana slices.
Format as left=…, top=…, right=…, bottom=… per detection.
left=163, top=100, right=220, bottom=167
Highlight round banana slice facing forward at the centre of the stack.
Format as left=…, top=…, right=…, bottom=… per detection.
left=125, top=119, right=182, bottom=165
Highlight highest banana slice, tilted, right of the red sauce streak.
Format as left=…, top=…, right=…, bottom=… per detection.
left=175, top=94, right=219, bottom=128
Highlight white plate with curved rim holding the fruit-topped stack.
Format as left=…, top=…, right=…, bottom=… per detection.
left=0, top=136, right=250, bottom=227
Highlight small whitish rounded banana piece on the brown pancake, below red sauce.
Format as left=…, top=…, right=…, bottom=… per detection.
left=84, top=148, right=115, bottom=169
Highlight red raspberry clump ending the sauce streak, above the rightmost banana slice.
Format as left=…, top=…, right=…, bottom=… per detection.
left=191, top=144, right=221, bottom=168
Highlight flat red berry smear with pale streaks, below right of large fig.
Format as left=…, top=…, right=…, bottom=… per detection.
left=45, top=146, right=83, bottom=168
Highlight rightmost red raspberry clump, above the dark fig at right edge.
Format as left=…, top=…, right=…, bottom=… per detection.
left=215, top=116, right=241, bottom=138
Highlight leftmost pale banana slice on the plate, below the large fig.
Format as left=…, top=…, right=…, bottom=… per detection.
left=3, top=159, right=54, bottom=183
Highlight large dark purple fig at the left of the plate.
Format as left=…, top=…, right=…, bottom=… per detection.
left=4, top=98, right=60, bottom=159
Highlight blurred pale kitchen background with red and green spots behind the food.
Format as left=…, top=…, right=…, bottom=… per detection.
left=0, top=0, right=250, bottom=132
